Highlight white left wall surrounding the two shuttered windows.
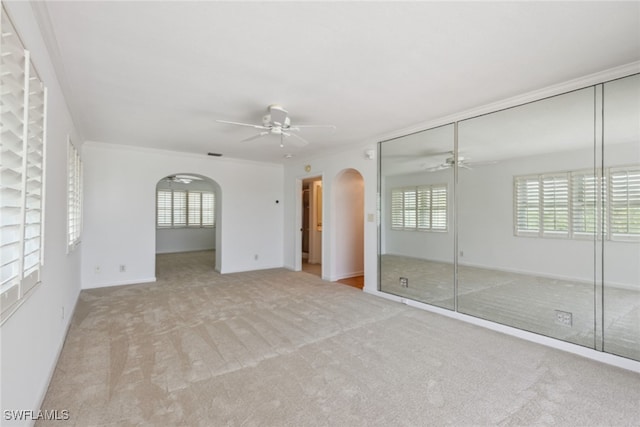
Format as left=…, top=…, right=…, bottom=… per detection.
left=0, top=2, right=83, bottom=426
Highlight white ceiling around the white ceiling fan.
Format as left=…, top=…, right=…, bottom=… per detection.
left=34, top=1, right=640, bottom=162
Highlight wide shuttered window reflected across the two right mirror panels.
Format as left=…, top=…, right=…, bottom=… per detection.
left=514, top=166, right=640, bottom=240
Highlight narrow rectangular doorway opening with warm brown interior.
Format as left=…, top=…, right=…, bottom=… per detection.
left=300, top=176, right=323, bottom=277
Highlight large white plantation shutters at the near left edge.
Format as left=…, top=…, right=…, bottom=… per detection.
left=0, top=7, right=46, bottom=321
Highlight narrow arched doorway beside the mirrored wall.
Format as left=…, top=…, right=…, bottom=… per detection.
left=333, top=169, right=364, bottom=289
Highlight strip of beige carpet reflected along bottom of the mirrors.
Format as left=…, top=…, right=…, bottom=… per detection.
left=381, top=255, right=640, bottom=360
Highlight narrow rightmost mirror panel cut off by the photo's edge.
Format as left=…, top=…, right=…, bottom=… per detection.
left=602, top=75, right=640, bottom=360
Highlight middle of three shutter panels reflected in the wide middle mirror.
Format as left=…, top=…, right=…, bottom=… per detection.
left=542, top=174, right=569, bottom=236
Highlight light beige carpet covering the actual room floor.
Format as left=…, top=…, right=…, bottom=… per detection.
left=37, top=252, right=640, bottom=426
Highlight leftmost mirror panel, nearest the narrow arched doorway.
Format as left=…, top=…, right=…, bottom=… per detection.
left=379, top=124, right=454, bottom=309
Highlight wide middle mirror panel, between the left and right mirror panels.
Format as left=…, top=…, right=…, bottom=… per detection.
left=458, top=88, right=596, bottom=348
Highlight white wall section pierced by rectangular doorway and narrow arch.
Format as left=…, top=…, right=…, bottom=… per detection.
left=284, top=144, right=378, bottom=290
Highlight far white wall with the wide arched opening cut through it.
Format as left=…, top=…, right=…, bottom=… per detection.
left=82, top=142, right=283, bottom=288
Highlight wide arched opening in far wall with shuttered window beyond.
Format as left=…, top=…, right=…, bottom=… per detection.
left=155, top=173, right=222, bottom=271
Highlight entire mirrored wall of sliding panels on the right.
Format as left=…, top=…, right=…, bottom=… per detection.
left=379, top=75, right=640, bottom=360
